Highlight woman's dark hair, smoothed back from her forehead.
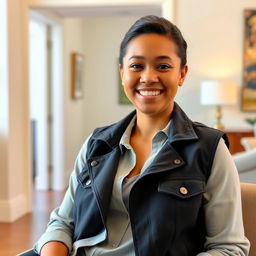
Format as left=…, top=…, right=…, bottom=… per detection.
left=119, top=15, right=187, bottom=68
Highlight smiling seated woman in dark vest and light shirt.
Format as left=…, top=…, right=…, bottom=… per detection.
left=32, top=16, right=249, bottom=256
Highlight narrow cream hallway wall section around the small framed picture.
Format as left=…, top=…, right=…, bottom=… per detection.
left=63, top=18, right=86, bottom=178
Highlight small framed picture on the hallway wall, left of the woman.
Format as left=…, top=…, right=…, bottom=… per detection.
left=71, top=52, right=84, bottom=99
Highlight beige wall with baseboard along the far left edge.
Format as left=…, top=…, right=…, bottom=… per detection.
left=0, top=0, right=31, bottom=221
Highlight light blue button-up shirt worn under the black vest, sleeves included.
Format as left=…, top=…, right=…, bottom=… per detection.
left=35, top=118, right=249, bottom=256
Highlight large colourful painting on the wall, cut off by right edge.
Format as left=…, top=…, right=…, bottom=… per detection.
left=242, top=9, right=256, bottom=111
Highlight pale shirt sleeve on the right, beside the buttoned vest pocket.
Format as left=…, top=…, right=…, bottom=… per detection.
left=199, top=139, right=250, bottom=256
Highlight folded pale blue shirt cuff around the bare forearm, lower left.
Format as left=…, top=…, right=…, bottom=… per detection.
left=34, top=230, right=72, bottom=254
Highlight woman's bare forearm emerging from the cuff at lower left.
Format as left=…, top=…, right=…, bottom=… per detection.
left=40, top=242, right=69, bottom=256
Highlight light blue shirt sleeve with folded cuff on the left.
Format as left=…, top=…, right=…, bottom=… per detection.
left=34, top=136, right=90, bottom=254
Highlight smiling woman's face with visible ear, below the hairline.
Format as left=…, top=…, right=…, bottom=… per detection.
left=120, top=33, right=187, bottom=118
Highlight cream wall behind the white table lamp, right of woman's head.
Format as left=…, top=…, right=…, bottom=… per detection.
left=176, top=0, right=256, bottom=128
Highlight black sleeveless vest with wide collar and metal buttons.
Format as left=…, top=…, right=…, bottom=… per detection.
left=74, top=104, right=228, bottom=256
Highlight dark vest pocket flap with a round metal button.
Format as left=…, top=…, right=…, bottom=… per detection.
left=158, top=180, right=205, bottom=199
